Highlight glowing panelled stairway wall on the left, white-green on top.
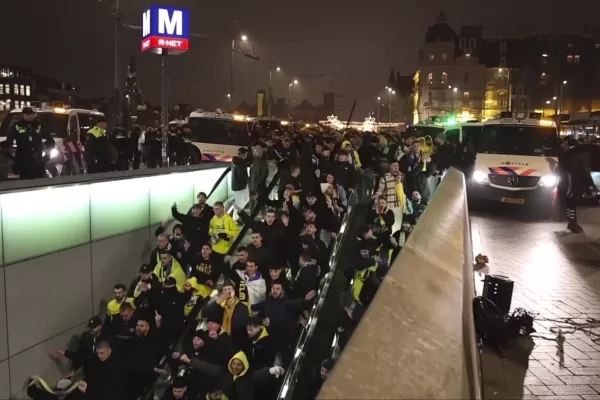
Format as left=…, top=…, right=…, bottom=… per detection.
left=0, top=163, right=233, bottom=399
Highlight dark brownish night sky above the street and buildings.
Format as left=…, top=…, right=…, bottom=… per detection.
left=0, top=0, right=600, bottom=119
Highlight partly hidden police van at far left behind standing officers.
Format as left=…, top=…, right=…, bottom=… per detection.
left=0, top=107, right=104, bottom=176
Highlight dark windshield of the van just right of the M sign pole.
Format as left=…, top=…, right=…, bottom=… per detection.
left=188, top=118, right=249, bottom=147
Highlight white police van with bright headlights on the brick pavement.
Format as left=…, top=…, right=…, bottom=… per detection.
left=468, top=118, right=559, bottom=215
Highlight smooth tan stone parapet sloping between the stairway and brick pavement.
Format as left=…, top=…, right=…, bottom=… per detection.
left=318, top=169, right=482, bottom=399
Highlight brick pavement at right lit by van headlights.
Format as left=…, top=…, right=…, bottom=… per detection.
left=471, top=208, right=600, bottom=400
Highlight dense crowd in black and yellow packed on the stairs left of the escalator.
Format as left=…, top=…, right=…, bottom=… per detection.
left=27, top=126, right=442, bottom=400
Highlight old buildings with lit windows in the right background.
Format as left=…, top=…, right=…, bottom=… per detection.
left=417, top=13, right=600, bottom=121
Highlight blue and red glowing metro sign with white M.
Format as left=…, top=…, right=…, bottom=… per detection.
left=141, top=6, right=190, bottom=54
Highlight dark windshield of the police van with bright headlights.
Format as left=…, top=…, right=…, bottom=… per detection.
left=477, top=125, right=559, bottom=157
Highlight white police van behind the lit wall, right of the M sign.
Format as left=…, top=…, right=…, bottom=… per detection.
left=188, top=110, right=252, bottom=163
